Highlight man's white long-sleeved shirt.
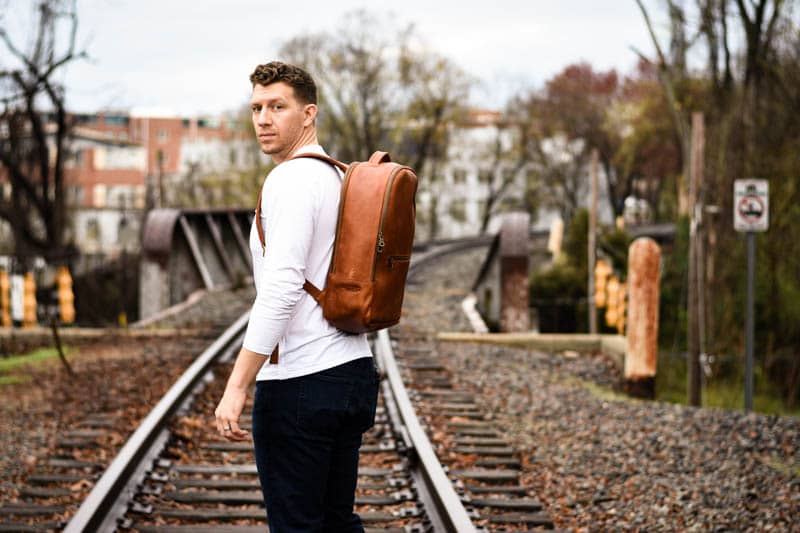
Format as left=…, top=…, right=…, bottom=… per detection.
left=244, top=145, right=372, bottom=381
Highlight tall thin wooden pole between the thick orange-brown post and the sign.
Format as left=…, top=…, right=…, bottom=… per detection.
left=686, top=112, right=705, bottom=406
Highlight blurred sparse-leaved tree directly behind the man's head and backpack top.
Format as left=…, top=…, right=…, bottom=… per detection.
left=279, top=11, right=471, bottom=173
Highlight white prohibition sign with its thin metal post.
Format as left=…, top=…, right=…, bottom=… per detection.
left=733, top=179, right=769, bottom=411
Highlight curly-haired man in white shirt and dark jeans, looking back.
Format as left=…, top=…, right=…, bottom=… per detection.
left=215, top=61, right=378, bottom=533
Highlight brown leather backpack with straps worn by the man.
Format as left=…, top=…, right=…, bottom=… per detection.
left=256, top=152, right=417, bottom=362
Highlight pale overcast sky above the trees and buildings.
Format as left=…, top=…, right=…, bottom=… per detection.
left=0, top=0, right=663, bottom=115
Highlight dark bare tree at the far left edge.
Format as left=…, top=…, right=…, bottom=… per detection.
left=0, top=0, right=86, bottom=259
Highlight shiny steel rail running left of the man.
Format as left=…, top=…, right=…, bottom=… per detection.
left=64, top=311, right=250, bottom=533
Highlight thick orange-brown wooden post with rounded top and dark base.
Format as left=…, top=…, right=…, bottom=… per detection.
left=624, top=237, right=661, bottom=399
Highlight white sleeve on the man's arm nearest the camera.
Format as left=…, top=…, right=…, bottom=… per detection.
left=243, top=161, right=318, bottom=356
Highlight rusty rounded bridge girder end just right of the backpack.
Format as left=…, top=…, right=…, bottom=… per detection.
left=500, top=212, right=530, bottom=333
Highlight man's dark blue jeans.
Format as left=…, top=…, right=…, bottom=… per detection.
left=253, top=357, right=378, bottom=533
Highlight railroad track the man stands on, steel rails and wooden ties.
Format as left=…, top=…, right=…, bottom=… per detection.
left=6, top=239, right=553, bottom=533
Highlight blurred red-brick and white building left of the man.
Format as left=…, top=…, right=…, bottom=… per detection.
left=57, top=111, right=252, bottom=255
